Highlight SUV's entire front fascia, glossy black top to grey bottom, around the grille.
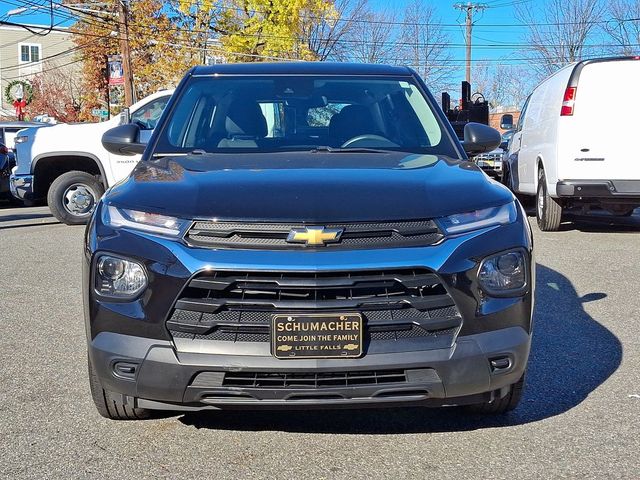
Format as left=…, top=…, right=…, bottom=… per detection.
left=83, top=202, right=534, bottom=410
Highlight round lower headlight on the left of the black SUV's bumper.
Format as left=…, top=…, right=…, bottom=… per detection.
left=95, top=255, right=147, bottom=298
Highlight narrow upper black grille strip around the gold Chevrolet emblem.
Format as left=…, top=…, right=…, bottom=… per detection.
left=185, top=220, right=443, bottom=250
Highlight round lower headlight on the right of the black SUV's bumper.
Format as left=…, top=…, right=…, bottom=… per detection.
left=478, top=250, right=529, bottom=297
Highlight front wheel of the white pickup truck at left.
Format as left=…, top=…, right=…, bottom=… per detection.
left=47, top=171, right=104, bottom=225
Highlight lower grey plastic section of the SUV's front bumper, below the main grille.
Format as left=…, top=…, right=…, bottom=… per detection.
left=89, top=327, right=531, bottom=410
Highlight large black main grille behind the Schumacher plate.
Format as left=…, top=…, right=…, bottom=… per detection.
left=167, top=269, right=462, bottom=348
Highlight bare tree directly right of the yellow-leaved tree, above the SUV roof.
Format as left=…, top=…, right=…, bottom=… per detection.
left=302, top=0, right=368, bottom=61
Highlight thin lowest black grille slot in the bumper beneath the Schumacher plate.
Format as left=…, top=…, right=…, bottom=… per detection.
left=222, top=370, right=407, bottom=388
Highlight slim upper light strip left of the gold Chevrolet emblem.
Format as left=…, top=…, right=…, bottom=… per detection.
left=102, top=205, right=190, bottom=237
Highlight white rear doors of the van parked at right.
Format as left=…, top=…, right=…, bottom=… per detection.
left=558, top=59, right=640, bottom=180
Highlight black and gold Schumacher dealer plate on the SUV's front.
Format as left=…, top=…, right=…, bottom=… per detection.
left=271, top=313, right=362, bottom=358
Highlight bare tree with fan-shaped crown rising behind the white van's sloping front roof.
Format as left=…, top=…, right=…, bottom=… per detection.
left=516, top=0, right=603, bottom=75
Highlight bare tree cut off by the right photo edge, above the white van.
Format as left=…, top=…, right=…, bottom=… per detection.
left=604, top=0, right=640, bottom=55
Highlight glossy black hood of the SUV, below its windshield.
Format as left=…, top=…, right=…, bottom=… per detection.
left=105, top=152, right=513, bottom=223
